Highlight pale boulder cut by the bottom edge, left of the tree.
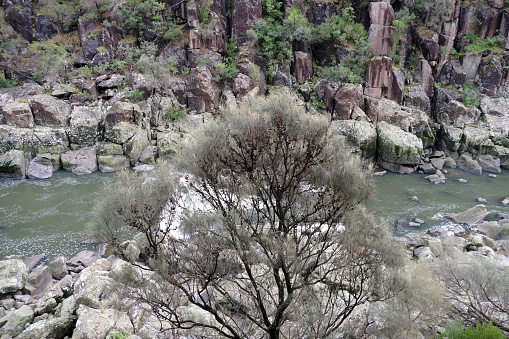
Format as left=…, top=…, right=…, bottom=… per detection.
left=72, top=305, right=134, bottom=339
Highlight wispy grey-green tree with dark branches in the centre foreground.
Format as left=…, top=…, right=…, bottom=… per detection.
left=97, top=95, right=401, bottom=338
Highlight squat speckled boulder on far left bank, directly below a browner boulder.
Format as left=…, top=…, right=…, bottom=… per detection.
left=31, top=127, right=69, bottom=154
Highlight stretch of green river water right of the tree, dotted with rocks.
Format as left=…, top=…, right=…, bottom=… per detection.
left=369, top=170, right=509, bottom=234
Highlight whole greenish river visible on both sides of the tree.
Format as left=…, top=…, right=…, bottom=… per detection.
left=0, top=170, right=509, bottom=259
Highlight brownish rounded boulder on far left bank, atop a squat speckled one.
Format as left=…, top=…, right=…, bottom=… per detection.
left=30, top=94, right=71, bottom=127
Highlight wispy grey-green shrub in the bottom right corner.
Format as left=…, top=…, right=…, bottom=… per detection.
left=436, top=255, right=509, bottom=334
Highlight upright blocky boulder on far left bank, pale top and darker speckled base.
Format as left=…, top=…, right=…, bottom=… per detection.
left=69, top=106, right=102, bottom=146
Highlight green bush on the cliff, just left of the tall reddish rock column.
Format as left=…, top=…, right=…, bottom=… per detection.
left=311, top=7, right=371, bottom=83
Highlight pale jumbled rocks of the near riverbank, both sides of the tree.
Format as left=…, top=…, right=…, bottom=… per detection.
left=0, top=205, right=509, bottom=339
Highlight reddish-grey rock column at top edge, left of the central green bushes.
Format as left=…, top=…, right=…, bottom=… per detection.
left=231, top=0, right=262, bottom=41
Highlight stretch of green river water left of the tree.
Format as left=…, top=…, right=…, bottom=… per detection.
left=0, top=171, right=111, bottom=259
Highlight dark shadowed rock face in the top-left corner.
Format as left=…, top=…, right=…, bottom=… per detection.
left=4, top=0, right=34, bottom=42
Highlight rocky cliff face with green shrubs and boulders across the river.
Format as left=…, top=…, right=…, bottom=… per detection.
left=0, top=0, right=509, bottom=177
